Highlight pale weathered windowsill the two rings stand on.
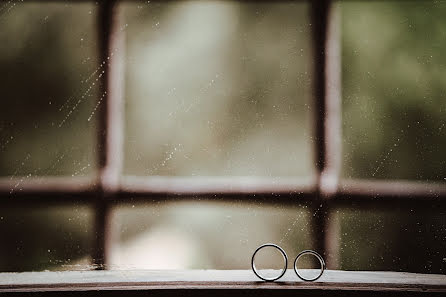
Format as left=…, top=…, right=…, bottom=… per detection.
left=0, top=270, right=446, bottom=296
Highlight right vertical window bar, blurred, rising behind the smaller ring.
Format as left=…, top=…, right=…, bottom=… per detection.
left=311, top=0, right=341, bottom=268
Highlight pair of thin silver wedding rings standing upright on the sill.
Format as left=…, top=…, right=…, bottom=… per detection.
left=251, top=243, right=325, bottom=282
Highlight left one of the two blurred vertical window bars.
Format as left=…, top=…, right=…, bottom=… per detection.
left=93, top=0, right=124, bottom=269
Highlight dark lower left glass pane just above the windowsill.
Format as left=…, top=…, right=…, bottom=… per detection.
left=0, top=206, right=93, bottom=272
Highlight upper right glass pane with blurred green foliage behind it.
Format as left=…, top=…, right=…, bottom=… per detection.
left=342, top=1, right=446, bottom=181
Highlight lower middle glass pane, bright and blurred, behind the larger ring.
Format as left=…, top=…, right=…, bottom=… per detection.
left=111, top=201, right=312, bottom=269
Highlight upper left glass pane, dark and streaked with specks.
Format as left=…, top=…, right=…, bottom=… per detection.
left=0, top=1, right=100, bottom=176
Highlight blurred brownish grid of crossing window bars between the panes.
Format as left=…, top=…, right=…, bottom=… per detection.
left=0, top=0, right=446, bottom=269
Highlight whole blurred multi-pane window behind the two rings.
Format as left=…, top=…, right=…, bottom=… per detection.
left=0, top=0, right=446, bottom=293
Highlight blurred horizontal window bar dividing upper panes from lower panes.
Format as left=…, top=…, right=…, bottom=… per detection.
left=0, top=176, right=446, bottom=207
